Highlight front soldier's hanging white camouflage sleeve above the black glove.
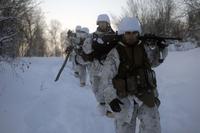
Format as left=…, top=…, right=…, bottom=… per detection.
left=101, top=49, right=120, bottom=103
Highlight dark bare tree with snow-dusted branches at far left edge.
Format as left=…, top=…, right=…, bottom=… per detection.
left=0, top=0, right=22, bottom=61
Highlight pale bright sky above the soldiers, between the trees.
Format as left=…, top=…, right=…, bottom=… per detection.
left=41, top=0, right=126, bottom=32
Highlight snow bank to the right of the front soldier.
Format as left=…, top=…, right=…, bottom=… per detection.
left=156, top=48, right=200, bottom=133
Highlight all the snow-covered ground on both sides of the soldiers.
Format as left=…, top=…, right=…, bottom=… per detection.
left=0, top=48, right=200, bottom=133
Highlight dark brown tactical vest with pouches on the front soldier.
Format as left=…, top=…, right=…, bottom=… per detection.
left=113, top=44, right=155, bottom=107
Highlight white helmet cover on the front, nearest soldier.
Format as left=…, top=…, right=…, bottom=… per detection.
left=118, top=17, right=141, bottom=35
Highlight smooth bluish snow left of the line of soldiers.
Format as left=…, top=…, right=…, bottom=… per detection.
left=0, top=58, right=114, bottom=133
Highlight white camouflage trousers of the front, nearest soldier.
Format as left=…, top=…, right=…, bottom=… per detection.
left=115, top=104, right=161, bottom=133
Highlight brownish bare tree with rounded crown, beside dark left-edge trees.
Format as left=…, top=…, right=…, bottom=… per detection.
left=23, top=9, right=47, bottom=56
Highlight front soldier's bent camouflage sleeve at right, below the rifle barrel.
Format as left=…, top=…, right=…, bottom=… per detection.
left=145, top=45, right=168, bottom=67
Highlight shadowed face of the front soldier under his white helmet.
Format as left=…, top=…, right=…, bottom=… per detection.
left=124, top=32, right=139, bottom=45
